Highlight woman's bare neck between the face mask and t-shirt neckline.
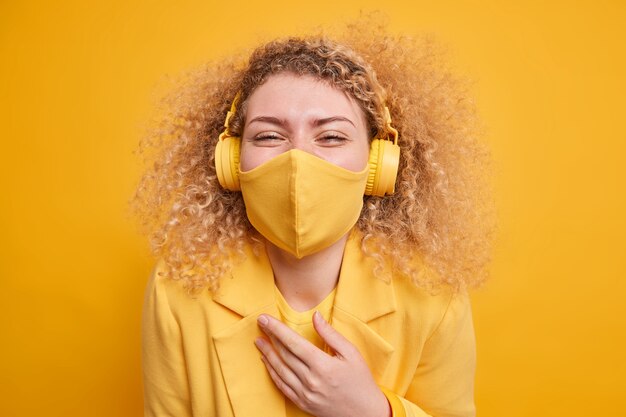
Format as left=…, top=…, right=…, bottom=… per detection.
left=265, top=233, right=349, bottom=311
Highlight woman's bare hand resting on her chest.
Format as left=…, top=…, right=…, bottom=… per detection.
left=255, top=311, right=391, bottom=417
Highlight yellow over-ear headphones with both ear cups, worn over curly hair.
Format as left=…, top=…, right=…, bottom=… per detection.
left=215, top=93, right=400, bottom=197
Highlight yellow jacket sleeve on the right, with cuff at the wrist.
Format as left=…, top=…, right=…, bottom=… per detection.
left=383, top=293, right=476, bottom=417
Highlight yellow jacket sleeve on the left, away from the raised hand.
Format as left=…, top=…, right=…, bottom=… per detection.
left=142, top=264, right=192, bottom=417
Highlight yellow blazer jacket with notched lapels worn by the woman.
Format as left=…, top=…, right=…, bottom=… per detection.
left=142, top=239, right=475, bottom=417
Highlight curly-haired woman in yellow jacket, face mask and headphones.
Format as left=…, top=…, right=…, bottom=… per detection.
left=136, top=23, right=491, bottom=417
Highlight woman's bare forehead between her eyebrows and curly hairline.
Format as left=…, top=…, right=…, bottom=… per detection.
left=246, top=73, right=365, bottom=124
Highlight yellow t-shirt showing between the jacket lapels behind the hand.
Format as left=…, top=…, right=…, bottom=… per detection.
left=274, top=286, right=336, bottom=417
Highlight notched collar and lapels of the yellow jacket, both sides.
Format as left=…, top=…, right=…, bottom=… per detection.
left=213, top=233, right=396, bottom=417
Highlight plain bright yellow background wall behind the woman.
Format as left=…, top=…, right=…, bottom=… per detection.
left=0, top=0, right=626, bottom=417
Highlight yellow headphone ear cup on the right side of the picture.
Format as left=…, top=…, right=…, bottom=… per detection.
left=365, top=139, right=400, bottom=197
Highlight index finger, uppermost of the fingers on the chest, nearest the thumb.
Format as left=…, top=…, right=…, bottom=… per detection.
left=258, top=314, right=326, bottom=367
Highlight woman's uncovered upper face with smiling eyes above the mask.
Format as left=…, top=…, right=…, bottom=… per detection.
left=240, top=73, right=369, bottom=172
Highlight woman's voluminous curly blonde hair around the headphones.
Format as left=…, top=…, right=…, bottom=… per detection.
left=131, top=17, right=495, bottom=293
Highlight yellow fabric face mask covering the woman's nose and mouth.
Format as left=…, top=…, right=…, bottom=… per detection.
left=239, top=149, right=369, bottom=258
